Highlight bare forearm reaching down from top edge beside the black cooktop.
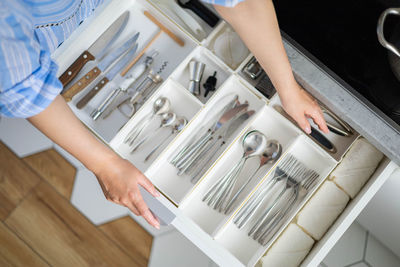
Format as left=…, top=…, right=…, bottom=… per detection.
left=215, top=0, right=296, bottom=94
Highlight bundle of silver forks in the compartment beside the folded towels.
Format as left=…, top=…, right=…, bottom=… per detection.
left=233, top=154, right=319, bottom=246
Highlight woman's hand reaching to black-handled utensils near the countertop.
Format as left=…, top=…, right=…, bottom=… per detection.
left=279, top=82, right=329, bottom=134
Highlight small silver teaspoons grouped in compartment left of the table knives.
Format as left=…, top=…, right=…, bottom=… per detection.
left=124, top=97, right=187, bottom=162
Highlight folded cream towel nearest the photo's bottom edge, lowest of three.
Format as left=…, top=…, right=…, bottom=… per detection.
left=261, top=223, right=314, bottom=267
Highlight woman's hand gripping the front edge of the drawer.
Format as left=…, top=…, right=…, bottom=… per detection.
left=95, top=155, right=160, bottom=229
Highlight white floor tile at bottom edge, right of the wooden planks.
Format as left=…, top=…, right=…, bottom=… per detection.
left=148, top=231, right=210, bottom=267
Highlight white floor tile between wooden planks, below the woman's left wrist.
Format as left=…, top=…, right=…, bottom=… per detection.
left=71, top=169, right=128, bottom=225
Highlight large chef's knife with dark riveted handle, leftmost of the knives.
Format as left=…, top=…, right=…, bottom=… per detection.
left=59, top=11, right=129, bottom=87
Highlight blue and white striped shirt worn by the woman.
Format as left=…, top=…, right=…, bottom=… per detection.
left=0, top=0, right=242, bottom=118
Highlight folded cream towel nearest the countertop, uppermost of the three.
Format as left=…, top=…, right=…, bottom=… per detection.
left=330, top=138, right=383, bottom=198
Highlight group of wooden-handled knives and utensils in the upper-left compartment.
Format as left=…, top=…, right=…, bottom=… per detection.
left=60, top=11, right=184, bottom=120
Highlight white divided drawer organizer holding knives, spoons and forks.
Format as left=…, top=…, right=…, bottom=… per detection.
left=54, top=0, right=397, bottom=267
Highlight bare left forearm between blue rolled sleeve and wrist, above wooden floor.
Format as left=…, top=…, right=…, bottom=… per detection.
left=28, top=96, right=116, bottom=173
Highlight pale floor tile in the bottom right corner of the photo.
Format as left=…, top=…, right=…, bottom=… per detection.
left=365, top=235, right=400, bottom=267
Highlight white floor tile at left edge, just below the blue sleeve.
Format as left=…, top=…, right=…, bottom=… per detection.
left=0, top=117, right=53, bottom=157
